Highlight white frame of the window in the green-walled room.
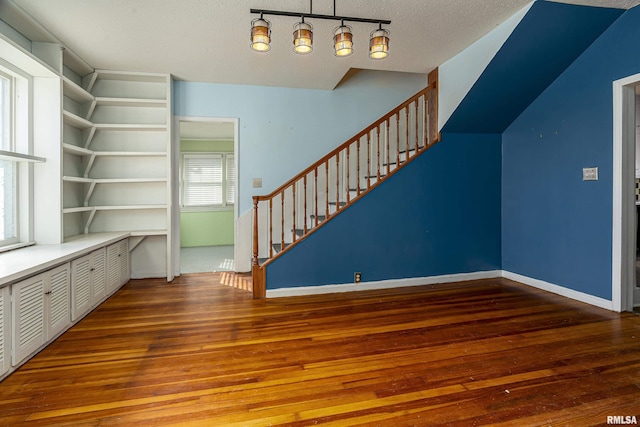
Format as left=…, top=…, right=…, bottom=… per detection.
left=180, top=151, right=237, bottom=212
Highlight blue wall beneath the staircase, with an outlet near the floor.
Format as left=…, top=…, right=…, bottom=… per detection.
left=267, top=134, right=501, bottom=289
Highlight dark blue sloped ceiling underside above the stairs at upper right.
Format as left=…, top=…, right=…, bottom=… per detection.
left=442, top=1, right=624, bottom=133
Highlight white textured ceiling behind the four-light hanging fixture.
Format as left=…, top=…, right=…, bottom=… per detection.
left=5, top=0, right=640, bottom=89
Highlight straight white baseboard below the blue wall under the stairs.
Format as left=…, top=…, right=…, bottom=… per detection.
left=267, top=270, right=502, bottom=298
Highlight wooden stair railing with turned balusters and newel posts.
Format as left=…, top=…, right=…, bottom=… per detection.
left=252, top=69, right=440, bottom=299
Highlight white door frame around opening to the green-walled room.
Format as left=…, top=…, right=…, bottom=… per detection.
left=171, top=116, right=240, bottom=276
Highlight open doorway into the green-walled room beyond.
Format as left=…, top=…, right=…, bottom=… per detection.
left=174, top=117, right=238, bottom=273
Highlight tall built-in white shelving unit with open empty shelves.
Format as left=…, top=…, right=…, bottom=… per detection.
left=62, top=70, right=171, bottom=278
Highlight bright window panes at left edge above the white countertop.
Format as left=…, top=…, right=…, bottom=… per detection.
left=0, top=72, right=18, bottom=247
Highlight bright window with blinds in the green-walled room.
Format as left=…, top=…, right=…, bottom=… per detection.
left=182, top=153, right=236, bottom=208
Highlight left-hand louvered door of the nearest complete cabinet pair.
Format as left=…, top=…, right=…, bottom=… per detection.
left=12, top=274, right=46, bottom=366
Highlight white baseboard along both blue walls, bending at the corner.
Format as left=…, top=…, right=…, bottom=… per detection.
left=267, top=270, right=615, bottom=311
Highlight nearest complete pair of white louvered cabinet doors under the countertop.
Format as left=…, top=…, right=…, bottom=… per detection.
left=11, top=263, right=71, bottom=365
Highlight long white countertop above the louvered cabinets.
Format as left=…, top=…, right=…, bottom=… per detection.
left=0, top=232, right=129, bottom=287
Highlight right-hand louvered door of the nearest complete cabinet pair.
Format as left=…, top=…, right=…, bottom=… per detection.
left=45, top=263, right=71, bottom=340
